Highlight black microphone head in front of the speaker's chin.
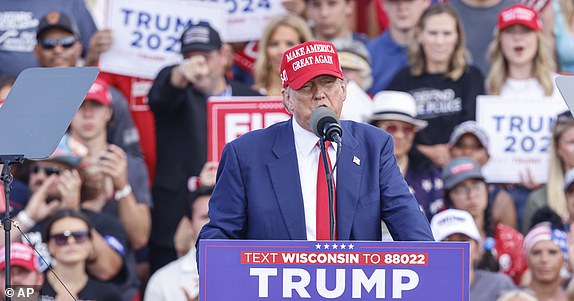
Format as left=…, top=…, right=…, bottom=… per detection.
left=309, top=107, right=343, bottom=143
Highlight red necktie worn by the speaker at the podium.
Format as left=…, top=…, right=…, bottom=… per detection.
left=316, top=141, right=337, bottom=240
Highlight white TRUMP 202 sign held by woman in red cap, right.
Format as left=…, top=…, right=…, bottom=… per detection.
left=476, top=96, right=568, bottom=183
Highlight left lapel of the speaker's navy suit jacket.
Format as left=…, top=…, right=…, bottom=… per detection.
left=267, top=119, right=307, bottom=240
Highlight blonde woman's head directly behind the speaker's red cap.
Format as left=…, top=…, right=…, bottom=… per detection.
left=253, top=14, right=312, bottom=95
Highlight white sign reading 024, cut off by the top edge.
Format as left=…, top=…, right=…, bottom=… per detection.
left=203, top=0, right=287, bottom=42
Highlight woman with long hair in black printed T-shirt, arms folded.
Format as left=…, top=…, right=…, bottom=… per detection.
left=388, top=3, right=484, bottom=166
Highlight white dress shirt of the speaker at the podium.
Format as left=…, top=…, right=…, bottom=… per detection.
left=293, top=118, right=337, bottom=240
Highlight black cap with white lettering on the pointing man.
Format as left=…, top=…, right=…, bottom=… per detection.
left=181, top=22, right=221, bottom=53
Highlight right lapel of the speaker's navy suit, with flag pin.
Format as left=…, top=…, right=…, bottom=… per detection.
left=336, top=123, right=364, bottom=240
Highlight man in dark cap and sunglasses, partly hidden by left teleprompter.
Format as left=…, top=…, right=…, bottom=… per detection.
left=34, top=11, right=142, bottom=162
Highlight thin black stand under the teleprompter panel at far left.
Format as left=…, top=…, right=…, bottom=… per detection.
left=0, top=155, right=24, bottom=301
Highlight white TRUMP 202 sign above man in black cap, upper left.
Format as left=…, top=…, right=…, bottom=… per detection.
left=100, top=0, right=227, bottom=79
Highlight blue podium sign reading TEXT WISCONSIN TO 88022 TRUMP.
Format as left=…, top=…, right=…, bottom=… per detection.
left=199, top=240, right=470, bottom=301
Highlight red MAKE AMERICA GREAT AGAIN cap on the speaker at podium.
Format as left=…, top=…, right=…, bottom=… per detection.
left=281, top=41, right=343, bottom=90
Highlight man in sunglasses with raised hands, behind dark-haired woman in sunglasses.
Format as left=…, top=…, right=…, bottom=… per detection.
left=0, top=135, right=125, bottom=280
